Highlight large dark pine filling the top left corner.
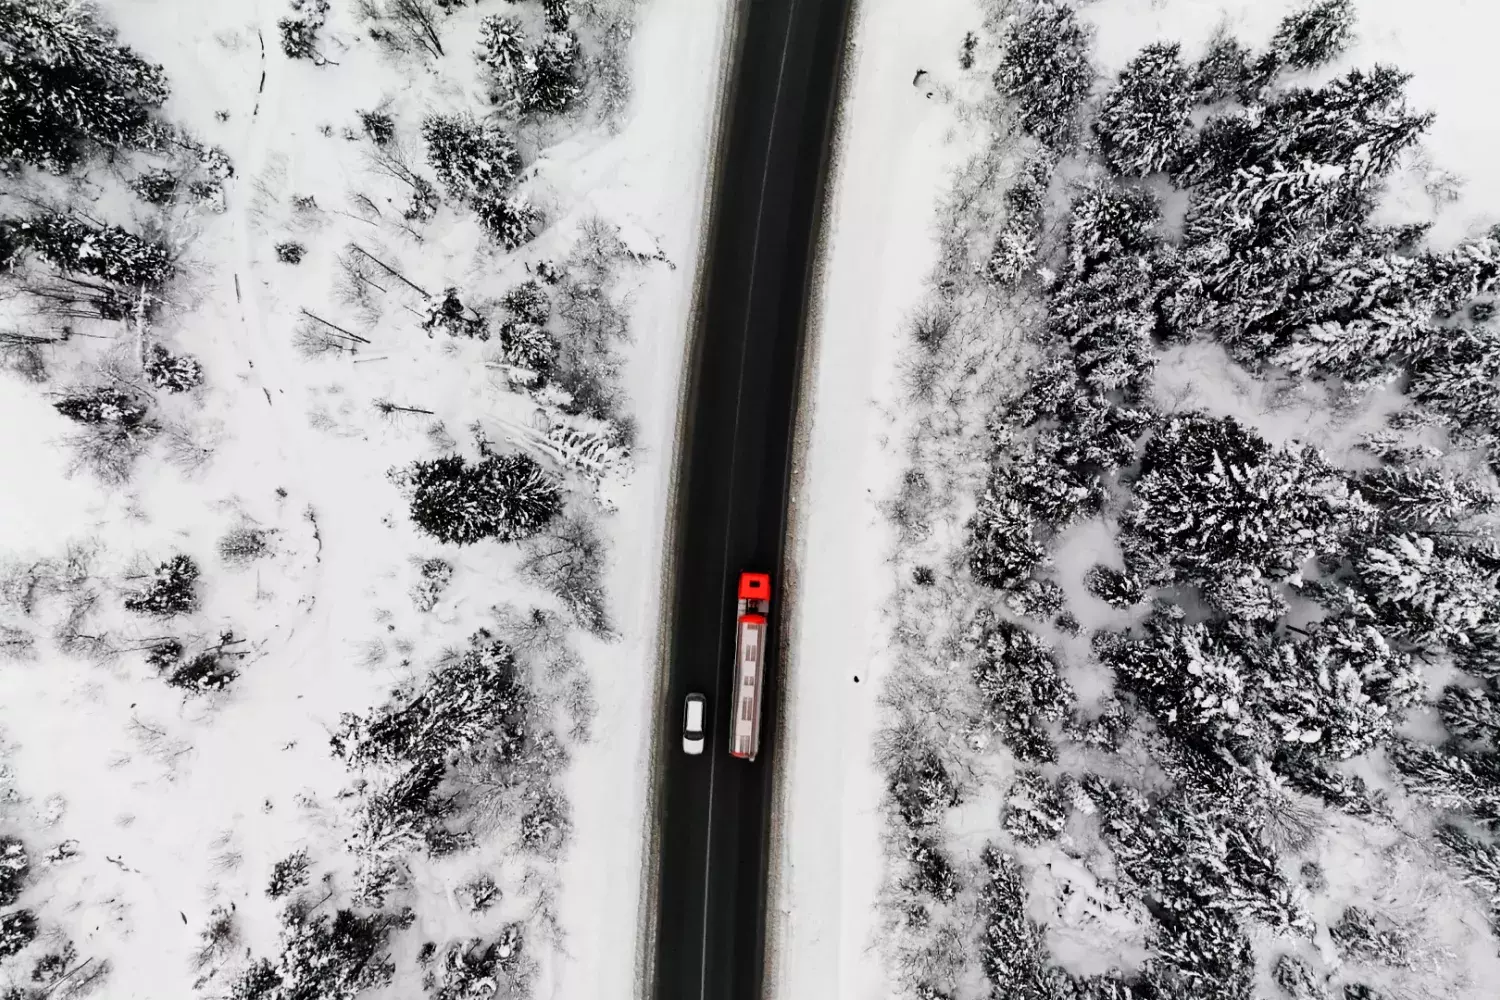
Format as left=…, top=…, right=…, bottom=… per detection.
left=0, top=0, right=168, bottom=172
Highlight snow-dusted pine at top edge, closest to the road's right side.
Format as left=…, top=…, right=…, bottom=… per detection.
left=995, top=0, right=1094, bottom=151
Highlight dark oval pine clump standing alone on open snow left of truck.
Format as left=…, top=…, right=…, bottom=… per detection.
left=396, top=454, right=563, bottom=546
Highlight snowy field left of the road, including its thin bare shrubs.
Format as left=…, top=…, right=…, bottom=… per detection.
left=0, top=0, right=729, bottom=999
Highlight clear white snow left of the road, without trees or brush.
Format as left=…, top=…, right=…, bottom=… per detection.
left=0, top=0, right=732, bottom=999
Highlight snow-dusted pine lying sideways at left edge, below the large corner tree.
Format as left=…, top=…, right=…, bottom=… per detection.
left=0, top=211, right=177, bottom=288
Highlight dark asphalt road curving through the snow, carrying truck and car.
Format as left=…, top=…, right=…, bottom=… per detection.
left=648, top=0, right=849, bottom=1000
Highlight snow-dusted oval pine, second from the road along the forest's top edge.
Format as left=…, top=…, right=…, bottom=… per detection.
left=1094, top=42, right=1193, bottom=177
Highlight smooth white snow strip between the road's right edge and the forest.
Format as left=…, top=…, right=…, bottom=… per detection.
left=767, top=0, right=981, bottom=1000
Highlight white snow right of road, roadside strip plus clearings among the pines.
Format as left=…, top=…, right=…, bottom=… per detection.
left=768, top=0, right=1500, bottom=1000
